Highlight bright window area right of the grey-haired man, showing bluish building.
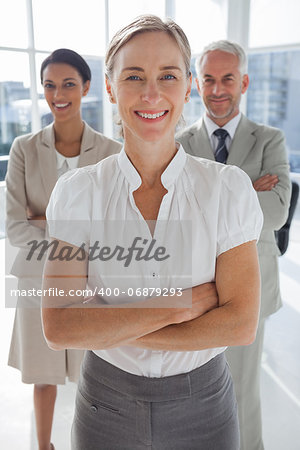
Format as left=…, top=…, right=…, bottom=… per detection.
left=247, top=0, right=300, bottom=173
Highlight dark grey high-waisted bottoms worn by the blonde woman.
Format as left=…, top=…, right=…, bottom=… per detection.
left=72, top=352, right=239, bottom=450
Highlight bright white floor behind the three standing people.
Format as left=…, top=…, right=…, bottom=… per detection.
left=0, top=222, right=300, bottom=450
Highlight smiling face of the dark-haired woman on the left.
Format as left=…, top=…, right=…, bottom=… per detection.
left=43, top=63, right=90, bottom=122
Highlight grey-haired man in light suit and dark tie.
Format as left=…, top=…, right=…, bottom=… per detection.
left=177, top=41, right=290, bottom=450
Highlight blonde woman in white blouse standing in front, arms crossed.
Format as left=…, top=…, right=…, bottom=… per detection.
left=43, top=16, right=262, bottom=450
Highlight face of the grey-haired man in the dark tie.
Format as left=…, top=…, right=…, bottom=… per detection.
left=196, top=50, right=249, bottom=127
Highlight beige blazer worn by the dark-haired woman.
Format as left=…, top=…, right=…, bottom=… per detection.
left=6, top=123, right=122, bottom=276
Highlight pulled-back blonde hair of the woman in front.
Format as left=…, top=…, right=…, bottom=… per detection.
left=105, top=14, right=191, bottom=78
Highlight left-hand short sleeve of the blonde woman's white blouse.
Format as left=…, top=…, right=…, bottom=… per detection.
left=46, top=168, right=92, bottom=247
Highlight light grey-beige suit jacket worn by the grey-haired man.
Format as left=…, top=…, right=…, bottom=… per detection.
left=177, top=115, right=291, bottom=317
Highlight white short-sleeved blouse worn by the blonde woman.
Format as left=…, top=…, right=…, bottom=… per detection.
left=46, top=146, right=263, bottom=377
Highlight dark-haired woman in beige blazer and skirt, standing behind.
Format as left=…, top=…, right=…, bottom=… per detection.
left=6, top=49, right=120, bottom=450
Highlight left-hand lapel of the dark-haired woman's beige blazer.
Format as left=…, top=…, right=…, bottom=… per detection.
left=37, top=124, right=57, bottom=198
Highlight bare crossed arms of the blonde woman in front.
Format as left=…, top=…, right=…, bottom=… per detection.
left=42, top=241, right=260, bottom=351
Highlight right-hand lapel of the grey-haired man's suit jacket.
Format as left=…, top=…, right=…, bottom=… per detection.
left=227, top=115, right=256, bottom=167
